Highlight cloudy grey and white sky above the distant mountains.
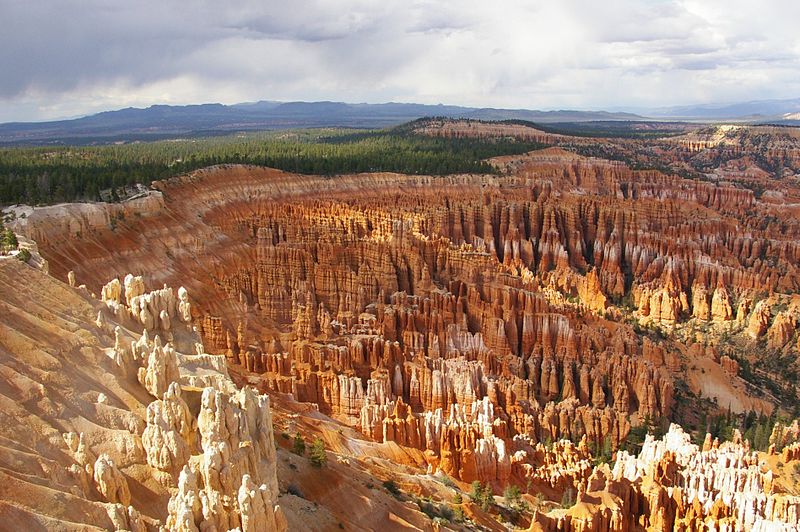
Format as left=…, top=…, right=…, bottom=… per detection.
left=0, top=0, right=800, bottom=122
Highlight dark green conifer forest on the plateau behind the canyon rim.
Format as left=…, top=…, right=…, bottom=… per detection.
left=0, top=125, right=543, bottom=205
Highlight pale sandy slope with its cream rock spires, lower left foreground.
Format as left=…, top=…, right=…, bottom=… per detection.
left=0, top=261, right=286, bottom=531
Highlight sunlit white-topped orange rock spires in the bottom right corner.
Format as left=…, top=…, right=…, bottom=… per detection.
left=530, top=424, right=800, bottom=531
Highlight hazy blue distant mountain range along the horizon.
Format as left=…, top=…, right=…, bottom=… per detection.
left=0, top=99, right=800, bottom=145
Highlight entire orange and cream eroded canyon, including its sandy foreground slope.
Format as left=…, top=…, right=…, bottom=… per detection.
left=0, top=121, right=800, bottom=531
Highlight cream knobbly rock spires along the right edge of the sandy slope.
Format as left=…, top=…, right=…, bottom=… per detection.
left=123, top=276, right=286, bottom=530
